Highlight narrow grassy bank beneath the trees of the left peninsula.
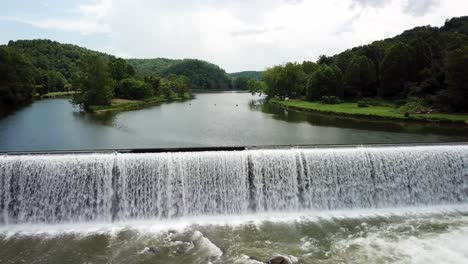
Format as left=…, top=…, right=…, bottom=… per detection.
left=91, top=93, right=192, bottom=114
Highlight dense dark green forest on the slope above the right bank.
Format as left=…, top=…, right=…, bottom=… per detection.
left=249, top=17, right=468, bottom=112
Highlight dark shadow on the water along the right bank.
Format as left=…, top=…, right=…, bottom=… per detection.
left=249, top=100, right=468, bottom=137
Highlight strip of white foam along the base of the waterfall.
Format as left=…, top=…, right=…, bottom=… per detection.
left=0, top=204, right=468, bottom=237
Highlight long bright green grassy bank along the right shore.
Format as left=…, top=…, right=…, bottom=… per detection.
left=270, top=99, right=468, bottom=124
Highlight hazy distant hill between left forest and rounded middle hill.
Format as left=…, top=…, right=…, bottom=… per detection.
left=127, top=58, right=182, bottom=76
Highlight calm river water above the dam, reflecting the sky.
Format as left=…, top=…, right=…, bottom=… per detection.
left=0, top=93, right=468, bottom=151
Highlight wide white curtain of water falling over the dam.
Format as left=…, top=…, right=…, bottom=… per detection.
left=0, top=145, right=468, bottom=224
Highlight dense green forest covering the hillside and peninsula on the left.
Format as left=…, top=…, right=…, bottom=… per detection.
left=0, top=40, right=190, bottom=115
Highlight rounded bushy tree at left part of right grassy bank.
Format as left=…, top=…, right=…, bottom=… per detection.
left=307, top=65, right=343, bottom=101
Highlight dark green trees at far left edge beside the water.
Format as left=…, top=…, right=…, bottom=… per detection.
left=0, top=46, right=33, bottom=116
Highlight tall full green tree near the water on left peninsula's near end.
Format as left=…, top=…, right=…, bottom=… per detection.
left=72, top=55, right=114, bottom=111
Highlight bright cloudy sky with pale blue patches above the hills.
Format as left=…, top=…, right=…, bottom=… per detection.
left=0, top=0, right=468, bottom=72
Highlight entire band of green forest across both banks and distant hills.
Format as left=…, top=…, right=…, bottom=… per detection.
left=0, top=17, right=468, bottom=115
